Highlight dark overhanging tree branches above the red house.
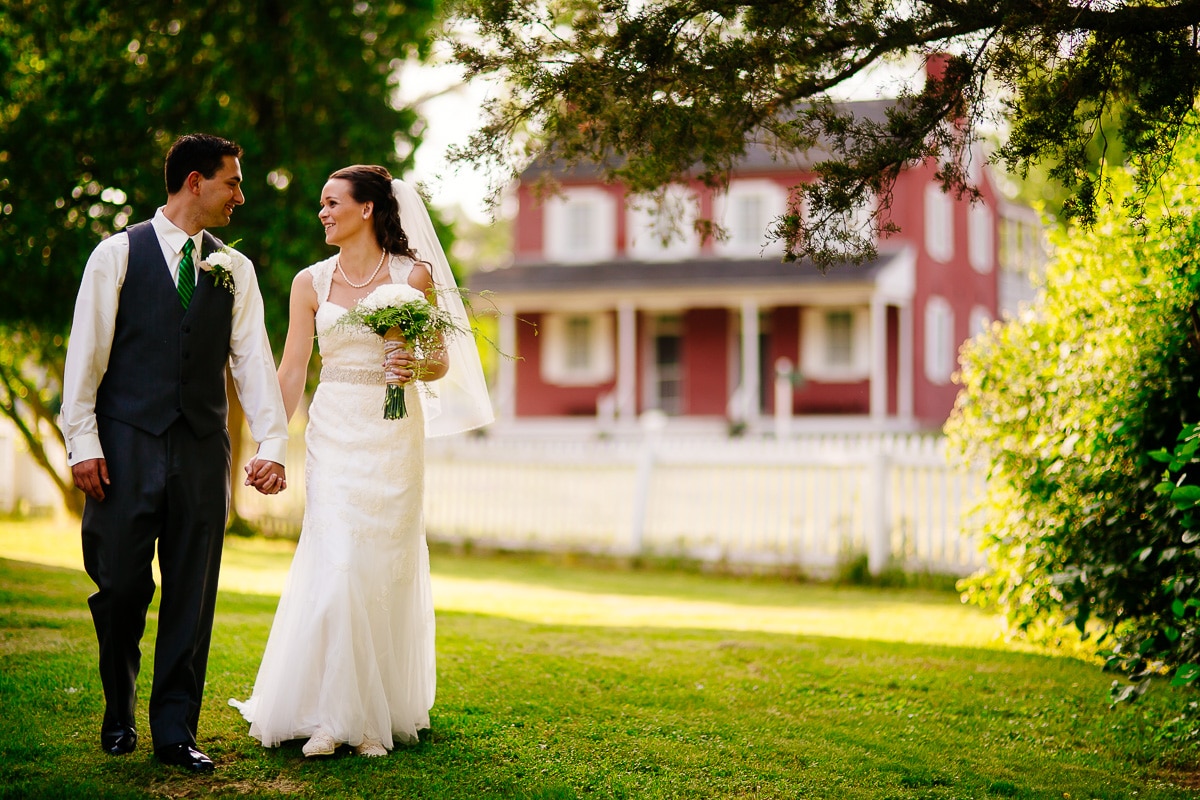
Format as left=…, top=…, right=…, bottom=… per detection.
left=451, top=0, right=1200, bottom=267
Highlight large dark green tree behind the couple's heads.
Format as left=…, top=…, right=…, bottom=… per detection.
left=0, top=0, right=434, bottom=515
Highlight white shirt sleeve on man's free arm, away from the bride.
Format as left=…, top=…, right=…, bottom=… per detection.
left=62, top=234, right=130, bottom=467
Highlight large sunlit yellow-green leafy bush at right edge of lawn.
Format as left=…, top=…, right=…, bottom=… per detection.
left=948, top=126, right=1200, bottom=724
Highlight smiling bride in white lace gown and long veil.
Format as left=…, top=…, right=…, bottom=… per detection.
left=229, top=166, right=492, bottom=757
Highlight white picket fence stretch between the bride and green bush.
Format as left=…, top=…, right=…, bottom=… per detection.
left=426, top=434, right=983, bottom=575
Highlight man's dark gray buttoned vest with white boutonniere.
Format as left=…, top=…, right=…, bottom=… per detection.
left=96, top=222, right=233, bottom=437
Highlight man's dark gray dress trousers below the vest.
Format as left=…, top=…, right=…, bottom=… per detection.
left=83, top=417, right=230, bottom=747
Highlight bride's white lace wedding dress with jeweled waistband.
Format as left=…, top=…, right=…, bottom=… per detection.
left=230, top=257, right=436, bottom=748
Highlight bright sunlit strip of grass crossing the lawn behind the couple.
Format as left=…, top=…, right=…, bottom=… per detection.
left=0, top=521, right=1012, bottom=648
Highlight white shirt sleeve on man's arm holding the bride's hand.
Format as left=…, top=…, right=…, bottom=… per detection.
left=229, top=255, right=288, bottom=464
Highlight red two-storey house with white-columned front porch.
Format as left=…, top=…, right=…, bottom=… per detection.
left=470, top=102, right=1040, bottom=431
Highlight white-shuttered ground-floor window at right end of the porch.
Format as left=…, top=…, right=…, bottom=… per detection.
left=800, top=307, right=870, bottom=381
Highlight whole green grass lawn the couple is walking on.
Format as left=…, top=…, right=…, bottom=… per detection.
left=0, top=515, right=1200, bottom=800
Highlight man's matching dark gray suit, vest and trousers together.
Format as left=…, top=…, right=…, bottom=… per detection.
left=83, top=223, right=233, bottom=748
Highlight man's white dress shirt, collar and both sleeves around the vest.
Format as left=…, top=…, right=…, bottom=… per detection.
left=62, top=207, right=288, bottom=465
